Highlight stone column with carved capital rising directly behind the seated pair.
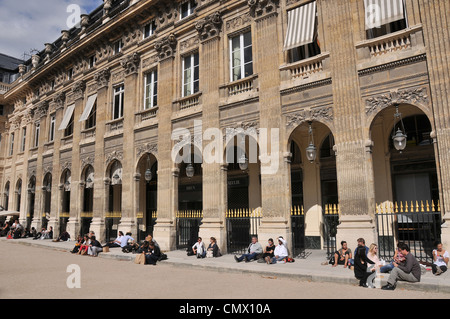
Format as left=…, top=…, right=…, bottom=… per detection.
left=195, top=12, right=227, bottom=252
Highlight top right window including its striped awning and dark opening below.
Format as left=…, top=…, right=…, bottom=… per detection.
left=364, top=0, right=408, bottom=39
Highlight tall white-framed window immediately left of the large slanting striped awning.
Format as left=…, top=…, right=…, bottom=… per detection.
left=230, top=31, right=253, bottom=82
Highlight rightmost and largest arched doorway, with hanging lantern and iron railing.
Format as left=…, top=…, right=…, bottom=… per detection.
left=370, top=104, right=442, bottom=262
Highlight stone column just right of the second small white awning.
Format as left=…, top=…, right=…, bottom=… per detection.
left=90, top=68, right=111, bottom=241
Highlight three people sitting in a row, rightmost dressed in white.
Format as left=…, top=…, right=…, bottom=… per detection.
left=234, top=236, right=294, bottom=264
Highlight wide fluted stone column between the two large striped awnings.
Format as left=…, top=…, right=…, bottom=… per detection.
left=322, top=0, right=376, bottom=247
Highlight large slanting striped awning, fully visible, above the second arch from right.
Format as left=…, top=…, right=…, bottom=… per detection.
left=284, top=1, right=316, bottom=51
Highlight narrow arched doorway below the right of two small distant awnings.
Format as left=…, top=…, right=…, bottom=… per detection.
left=80, top=165, right=94, bottom=236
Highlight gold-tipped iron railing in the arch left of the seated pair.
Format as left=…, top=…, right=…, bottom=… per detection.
left=176, top=210, right=203, bottom=249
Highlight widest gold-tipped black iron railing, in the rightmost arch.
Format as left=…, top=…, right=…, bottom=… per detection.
left=375, top=201, right=442, bottom=263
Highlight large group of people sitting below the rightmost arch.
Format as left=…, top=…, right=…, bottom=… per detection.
left=330, top=238, right=450, bottom=290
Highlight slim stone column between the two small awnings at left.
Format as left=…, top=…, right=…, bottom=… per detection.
left=67, top=81, right=86, bottom=239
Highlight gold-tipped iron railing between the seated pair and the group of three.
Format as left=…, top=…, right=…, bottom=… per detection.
left=226, top=208, right=262, bottom=254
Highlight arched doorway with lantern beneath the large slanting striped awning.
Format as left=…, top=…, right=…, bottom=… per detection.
left=288, top=121, right=338, bottom=255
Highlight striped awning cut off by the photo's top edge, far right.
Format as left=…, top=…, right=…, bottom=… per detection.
left=364, top=0, right=405, bottom=30
